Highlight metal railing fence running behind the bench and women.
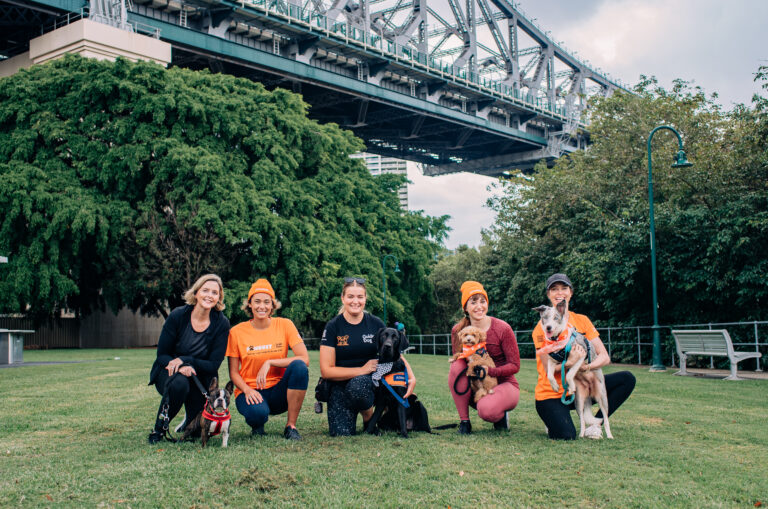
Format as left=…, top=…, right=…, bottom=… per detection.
left=396, top=321, right=768, bottom=371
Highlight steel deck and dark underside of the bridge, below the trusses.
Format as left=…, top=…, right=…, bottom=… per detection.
left=0, top=0, right=607, bottom=175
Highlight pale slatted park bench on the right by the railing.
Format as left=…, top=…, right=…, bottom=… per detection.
left=672, top=329, right=762, bottom=380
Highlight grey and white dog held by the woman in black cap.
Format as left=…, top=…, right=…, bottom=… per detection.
left=533, top=301, right=613, bottom=438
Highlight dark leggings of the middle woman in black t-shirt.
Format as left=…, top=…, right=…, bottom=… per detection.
left=328, top=375, right=374, bottom=437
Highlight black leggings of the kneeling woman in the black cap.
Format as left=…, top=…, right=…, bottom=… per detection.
left=536, top=371, right=635, bottom=440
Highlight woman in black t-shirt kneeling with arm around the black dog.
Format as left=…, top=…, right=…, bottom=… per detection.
left=320, top=278, right=416, bottom=436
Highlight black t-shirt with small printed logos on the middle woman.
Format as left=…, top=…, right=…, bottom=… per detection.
left=320, top=313, right=384, bottom=368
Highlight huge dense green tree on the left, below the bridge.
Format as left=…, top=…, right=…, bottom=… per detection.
left=0, top=56, right=446, bottom=332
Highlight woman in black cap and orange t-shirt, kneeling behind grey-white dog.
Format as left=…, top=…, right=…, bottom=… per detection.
left=532, top=274, right=635, bottom=440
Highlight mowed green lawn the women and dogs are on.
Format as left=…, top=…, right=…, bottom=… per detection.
left=0, top=350, right=768, bottom=508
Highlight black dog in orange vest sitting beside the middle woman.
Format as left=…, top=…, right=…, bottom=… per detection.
left=365, top=327, right=408, bottom=438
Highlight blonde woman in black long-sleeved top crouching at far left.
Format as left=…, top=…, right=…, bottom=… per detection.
left=149, top=274, right=229, bottom=444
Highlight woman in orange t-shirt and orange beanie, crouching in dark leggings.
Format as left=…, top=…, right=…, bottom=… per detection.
left=227, top=279, right=309, bottom=440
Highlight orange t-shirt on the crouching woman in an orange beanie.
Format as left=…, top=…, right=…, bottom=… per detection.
left=226, top=317, right=302, bottom=397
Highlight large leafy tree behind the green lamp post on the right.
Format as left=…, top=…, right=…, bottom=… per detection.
left=484, top=75, right=768, bottom=340
